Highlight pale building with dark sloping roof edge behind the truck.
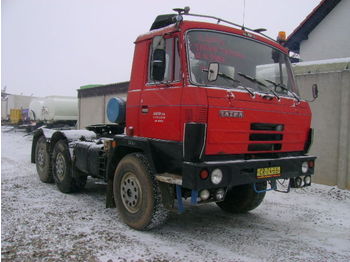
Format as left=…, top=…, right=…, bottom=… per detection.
left=286, top=0, right=350, bottom=61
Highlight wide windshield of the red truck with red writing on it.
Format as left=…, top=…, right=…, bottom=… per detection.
left=187, top=30, right=298, bottom=96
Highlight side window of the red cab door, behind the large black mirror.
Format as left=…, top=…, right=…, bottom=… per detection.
left=148, top=38, right=181, bottom=83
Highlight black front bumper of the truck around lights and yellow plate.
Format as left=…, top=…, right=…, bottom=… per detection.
left=182, top=156, right=316, bottom=190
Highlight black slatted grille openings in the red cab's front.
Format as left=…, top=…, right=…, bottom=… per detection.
left=248, top=123, right=284, bottom=152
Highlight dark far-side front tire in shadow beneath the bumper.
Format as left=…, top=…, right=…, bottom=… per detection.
left=216, top=181, right=267, bottom=214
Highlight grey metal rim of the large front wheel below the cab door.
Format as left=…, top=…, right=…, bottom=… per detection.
left=120, top=172, right=142, bottom=213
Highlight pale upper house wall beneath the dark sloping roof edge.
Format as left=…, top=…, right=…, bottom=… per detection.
left=300, top=0, right=350, bottom=61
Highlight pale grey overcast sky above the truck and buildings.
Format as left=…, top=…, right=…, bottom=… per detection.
left=1, top=0, right=320, bottom=96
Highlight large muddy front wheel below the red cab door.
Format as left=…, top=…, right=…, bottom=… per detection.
left=113, top=153, right=169, bottom=230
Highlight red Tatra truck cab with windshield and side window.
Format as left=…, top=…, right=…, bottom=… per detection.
left=126, top=12, right=311, bottom=174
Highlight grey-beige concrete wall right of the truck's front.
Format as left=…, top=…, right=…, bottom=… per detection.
left=294, top=59, right=350, bottom=189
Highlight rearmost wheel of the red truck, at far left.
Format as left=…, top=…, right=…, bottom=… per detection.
left=35, top=136, right=53, bottom=183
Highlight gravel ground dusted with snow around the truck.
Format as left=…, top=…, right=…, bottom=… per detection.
left=1, top=127, right=350, bottom=262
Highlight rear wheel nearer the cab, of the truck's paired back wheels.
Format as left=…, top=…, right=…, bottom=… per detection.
left=52, top=140, right=87, bottom=193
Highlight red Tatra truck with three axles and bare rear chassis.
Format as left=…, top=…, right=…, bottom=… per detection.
left=31, top=8, right=317, bottom=230
